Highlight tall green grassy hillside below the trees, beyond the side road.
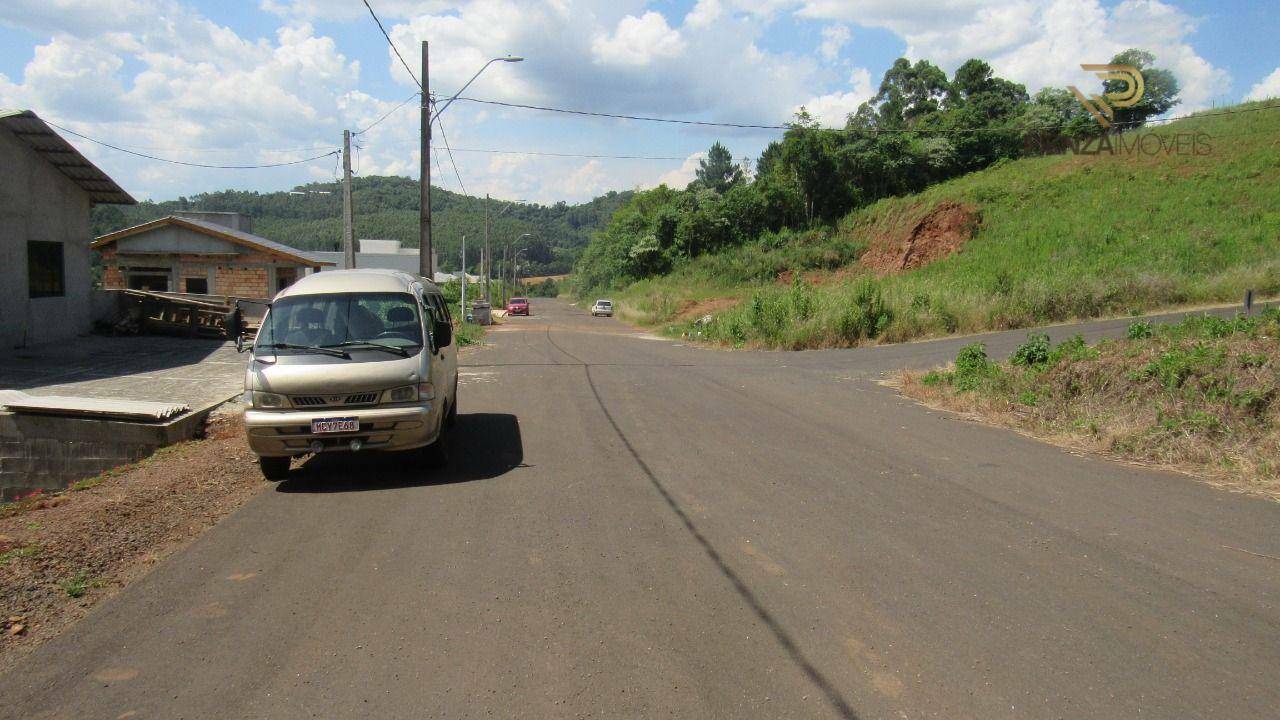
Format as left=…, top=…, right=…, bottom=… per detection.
left=614, top=104, right=1280, bottom=348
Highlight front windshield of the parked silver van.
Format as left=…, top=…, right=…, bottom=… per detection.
left=255, top=292, right=422, bottom=352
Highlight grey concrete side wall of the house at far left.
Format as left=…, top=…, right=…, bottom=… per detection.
left=0, top=128, right=92, bottom=351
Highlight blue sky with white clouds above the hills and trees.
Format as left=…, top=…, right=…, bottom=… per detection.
left=0, top=0, right=1280, bottom=204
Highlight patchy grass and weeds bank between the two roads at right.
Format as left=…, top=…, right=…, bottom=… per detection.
left=904, top=304, right=1280, bottom=496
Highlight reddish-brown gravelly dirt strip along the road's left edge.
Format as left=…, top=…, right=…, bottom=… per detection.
left=0, top=414, right=266, bottom=670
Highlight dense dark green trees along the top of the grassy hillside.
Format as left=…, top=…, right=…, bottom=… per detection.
left=576, top=50, right=1179, bottom=292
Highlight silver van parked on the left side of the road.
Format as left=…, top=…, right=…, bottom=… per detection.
left=237, top=269, right=458, bottom=479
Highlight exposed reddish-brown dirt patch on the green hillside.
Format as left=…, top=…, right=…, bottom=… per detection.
left=859, top=201, right=982, bottom=275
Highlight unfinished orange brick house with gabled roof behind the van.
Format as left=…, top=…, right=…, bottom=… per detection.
left=91, top=211, right=333, bottom=299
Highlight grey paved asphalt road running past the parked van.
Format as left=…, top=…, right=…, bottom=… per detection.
left=0, top=295, right=1280, bottom=720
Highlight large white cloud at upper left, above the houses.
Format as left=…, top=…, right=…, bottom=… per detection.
left=0, top=0, right=371, bottom=197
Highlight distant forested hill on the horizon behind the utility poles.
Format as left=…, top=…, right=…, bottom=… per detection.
left=92, top=176, right=631, bottom=275
